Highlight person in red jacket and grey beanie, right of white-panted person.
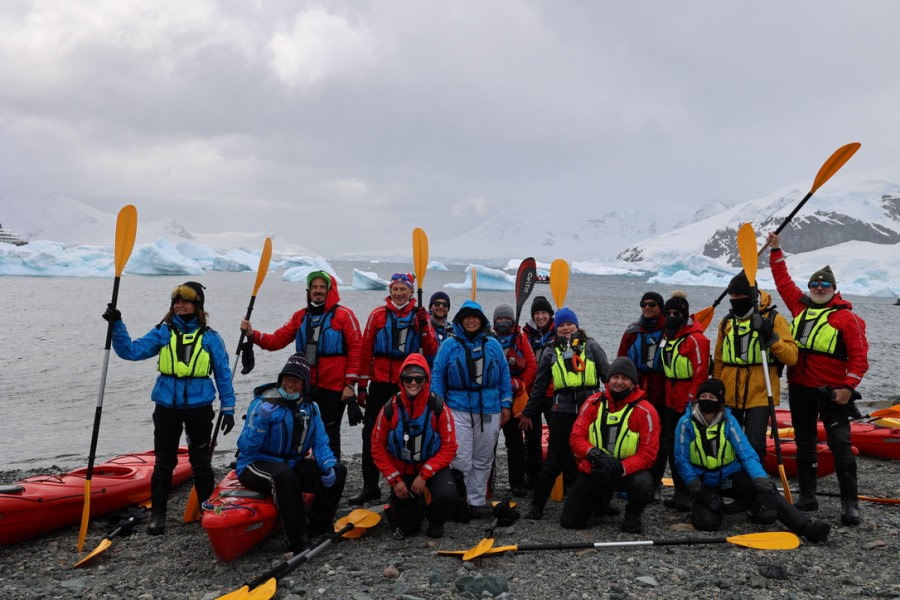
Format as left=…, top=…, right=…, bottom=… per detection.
left=494, top=304, right=537, bottom=497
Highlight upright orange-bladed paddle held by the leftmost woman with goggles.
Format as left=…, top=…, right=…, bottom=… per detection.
left=78, top=204, right=137, bottom=552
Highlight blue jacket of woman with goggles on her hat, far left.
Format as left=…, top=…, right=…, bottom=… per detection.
left=112, top=315, right=235, bottom=415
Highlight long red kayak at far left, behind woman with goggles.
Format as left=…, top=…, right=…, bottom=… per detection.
left=0, top=447, right=191, bottom=546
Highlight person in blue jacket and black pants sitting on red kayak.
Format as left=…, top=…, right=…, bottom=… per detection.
left=237, top=352, right=347, bottom=554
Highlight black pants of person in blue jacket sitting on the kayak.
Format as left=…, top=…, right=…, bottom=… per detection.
left=238, top=458, right=347, bottom=546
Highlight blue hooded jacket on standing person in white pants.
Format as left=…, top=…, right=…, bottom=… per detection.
left=431, top=300, right=512, bottom=414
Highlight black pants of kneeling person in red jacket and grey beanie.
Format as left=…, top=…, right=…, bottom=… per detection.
left=559, top=469, right=653, bottom=529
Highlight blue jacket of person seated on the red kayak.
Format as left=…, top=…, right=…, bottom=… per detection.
left=236, top=383, right=338, bottom=475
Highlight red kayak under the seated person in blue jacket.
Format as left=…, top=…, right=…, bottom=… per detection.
left=200, top=471, right=313, bottom=562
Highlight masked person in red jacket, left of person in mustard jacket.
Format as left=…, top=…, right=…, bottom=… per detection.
left=661, top=290, right=709, bottom=512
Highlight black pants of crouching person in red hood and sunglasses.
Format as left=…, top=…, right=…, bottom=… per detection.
left=388, top=469, right=459, bottom=535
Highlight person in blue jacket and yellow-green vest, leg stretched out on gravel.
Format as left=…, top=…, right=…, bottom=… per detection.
left=675, top=379, right=831, bottom=544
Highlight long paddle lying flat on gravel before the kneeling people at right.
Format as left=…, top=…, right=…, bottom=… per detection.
left=437, top=531, right=800, bottom=557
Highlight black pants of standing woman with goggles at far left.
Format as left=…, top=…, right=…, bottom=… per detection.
left=151, top=404, right=215, bottom=508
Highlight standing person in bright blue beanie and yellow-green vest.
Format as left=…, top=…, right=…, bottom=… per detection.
left=519, top=307, right=609, bottom=520
